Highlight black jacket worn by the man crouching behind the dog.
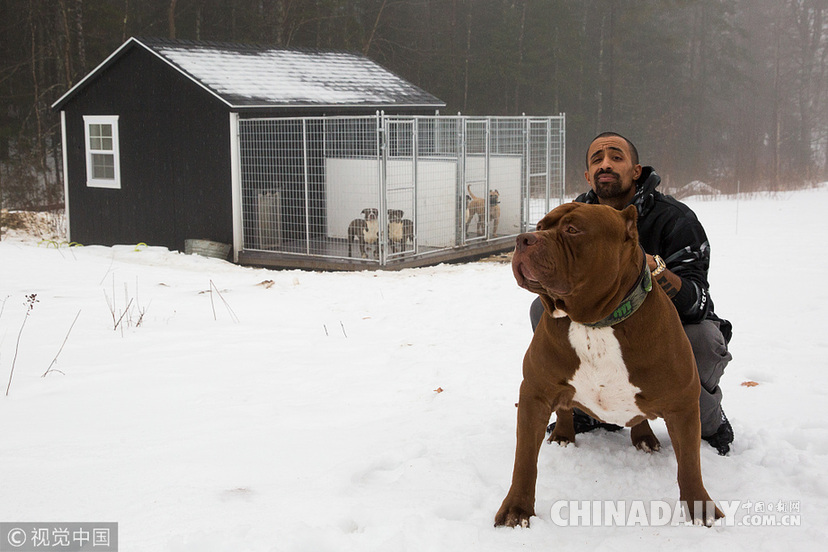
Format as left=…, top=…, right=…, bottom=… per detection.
left=575, top=167, right=730, bottom=339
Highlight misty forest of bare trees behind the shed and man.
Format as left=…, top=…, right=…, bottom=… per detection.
left=0, top=0, right=828, bottom=207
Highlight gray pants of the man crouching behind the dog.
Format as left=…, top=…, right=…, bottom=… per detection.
left=529, top=297, right=732, bottom=436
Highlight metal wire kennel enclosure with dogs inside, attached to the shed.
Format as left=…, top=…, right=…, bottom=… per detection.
left=236, top=113, right=565, bottom=268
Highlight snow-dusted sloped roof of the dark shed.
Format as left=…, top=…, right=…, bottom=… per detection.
left=52, top=38, right=445, bottom=109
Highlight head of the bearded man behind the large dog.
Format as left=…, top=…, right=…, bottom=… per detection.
left=584, top=136, right=641, bottom=209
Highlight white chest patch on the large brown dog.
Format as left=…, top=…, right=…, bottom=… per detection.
left=569, top=322, right=644, bottom=426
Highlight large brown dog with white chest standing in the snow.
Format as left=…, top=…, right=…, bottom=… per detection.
left=495, top=203, right=722, bottom=526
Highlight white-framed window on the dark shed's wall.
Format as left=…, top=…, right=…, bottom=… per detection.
left=83, top=115, right=121, bottom=188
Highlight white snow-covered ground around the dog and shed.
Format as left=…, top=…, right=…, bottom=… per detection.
left=0, top=186, right=828, bottom=552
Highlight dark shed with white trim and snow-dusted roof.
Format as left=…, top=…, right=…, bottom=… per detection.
left=53, top=38, right=445, bottom=261
